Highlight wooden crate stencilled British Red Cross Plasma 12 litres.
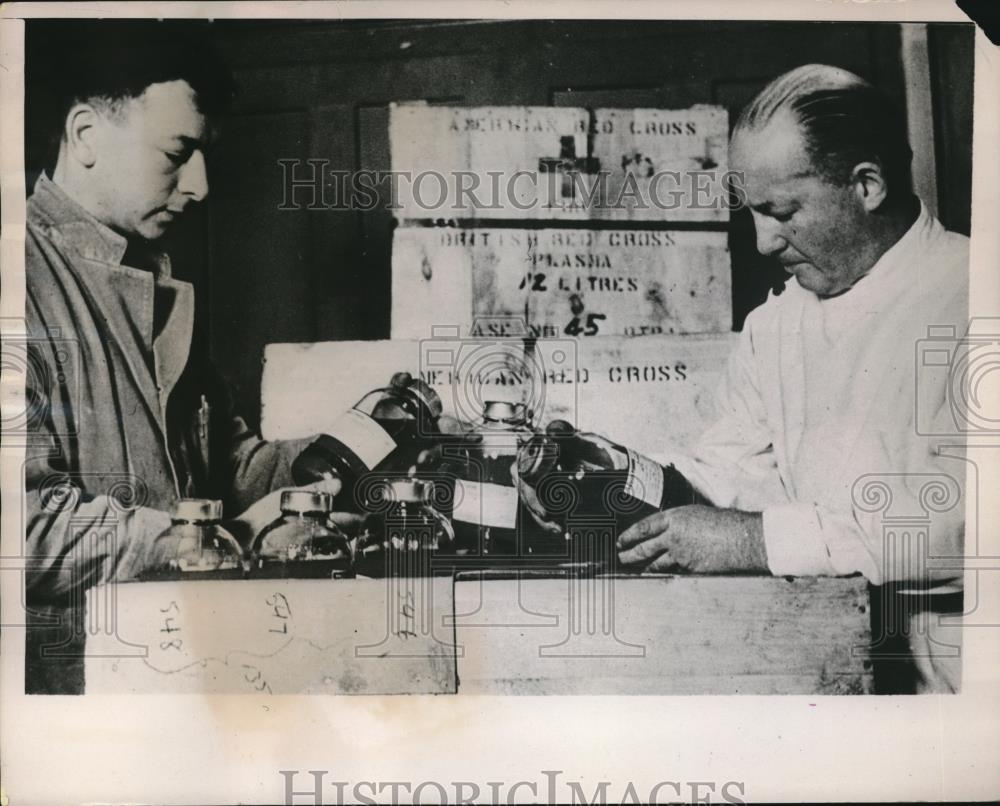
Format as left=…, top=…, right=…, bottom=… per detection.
left=391, top=227, right=732, bottom=338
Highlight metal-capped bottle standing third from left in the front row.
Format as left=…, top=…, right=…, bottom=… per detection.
left=354, top=478, right=455, bottom=577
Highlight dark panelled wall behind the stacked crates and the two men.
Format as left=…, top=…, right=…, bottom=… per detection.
left=26, top=20, right=973, bottom=430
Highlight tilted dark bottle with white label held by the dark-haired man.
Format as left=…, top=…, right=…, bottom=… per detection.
left=292, top=372, right=442, bottom=510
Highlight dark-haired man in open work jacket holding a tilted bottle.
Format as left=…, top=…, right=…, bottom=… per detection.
left=25, top=23, right=336, bottom=692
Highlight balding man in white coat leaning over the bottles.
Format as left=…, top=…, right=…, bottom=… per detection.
left=619, top=65, right=968, bottom=687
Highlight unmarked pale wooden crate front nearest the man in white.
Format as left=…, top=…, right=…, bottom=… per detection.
left=455, top=577, right=872, bottom=694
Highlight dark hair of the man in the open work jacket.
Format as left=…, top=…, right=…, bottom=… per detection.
left=25, top=20, right=235, bottom=170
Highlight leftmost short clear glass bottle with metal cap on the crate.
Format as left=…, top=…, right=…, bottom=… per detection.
left=141, top=498, right=244, bottom=580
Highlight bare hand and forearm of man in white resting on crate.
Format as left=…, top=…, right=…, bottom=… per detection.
left=618, top=504, right=768, bottom=574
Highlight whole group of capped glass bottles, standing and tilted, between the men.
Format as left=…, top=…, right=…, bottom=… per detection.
left=147, top=373, right=695, bottom=578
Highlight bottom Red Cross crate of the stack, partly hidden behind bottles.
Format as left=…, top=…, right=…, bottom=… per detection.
left=262, top=330, right=738, bottom=455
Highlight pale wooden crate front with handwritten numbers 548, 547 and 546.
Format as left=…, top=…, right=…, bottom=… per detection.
left=85, top=578, right=455, bottom=694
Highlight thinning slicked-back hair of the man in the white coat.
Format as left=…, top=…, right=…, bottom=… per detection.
left=734, top=64, right=913, bottom=198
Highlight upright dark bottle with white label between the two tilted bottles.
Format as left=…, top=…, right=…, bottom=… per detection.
left=449, top=401, right=535, bottom=564
